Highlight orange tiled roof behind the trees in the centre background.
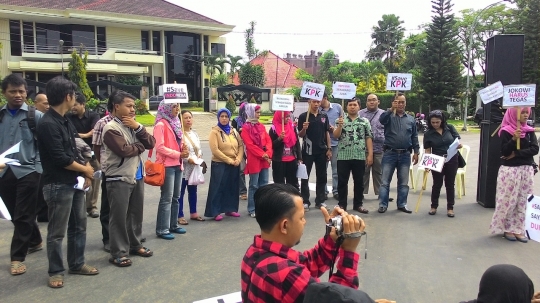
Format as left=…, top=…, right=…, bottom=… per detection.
left=233, top=51, right=303, bottom=88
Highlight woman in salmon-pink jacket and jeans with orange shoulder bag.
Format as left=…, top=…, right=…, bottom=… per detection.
left=154, top=101, right=189, bottom=240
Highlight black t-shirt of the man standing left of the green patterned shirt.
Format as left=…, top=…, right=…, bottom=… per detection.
left=298, top=112, right=330, bottom=155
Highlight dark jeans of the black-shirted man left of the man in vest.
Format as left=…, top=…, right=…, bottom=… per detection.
left=43, top=183, right=86, bottom=276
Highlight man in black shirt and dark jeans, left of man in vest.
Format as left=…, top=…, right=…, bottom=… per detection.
left=37, top=76, right=99, bottom=288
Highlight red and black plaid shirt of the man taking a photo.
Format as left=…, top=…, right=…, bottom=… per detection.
left=241, top=235, right=360, bottom=303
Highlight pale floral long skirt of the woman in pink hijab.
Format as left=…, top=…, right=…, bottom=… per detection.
left=489, top=165, right=534, bottom=234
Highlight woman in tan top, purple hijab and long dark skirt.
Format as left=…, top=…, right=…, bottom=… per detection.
left=204, top=108, right=244, bottom=221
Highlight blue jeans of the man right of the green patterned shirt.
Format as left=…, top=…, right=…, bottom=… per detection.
left=379, top=150, right=411, bottom=208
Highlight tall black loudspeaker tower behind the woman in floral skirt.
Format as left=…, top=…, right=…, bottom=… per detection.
left=476, top=35, right=525, bottom=208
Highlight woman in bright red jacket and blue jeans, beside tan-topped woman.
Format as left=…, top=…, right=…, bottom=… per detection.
left=242, top=103, right=272, bottom=218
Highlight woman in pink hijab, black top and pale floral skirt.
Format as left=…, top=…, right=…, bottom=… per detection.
left=489, top=107, right=538, bottom=243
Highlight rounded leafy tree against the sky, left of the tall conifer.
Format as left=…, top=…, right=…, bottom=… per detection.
left=367, top=14, right=405, bottom=72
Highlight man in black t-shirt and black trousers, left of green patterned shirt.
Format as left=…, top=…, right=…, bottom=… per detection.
left=298, top=99, right=332, bottom=211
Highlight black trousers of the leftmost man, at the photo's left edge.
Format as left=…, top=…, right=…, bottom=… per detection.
left=0, top=168, right=42, bottom=262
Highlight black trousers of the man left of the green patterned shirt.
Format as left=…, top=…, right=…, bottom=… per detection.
left=301, top=153, right=327, bottom=205
